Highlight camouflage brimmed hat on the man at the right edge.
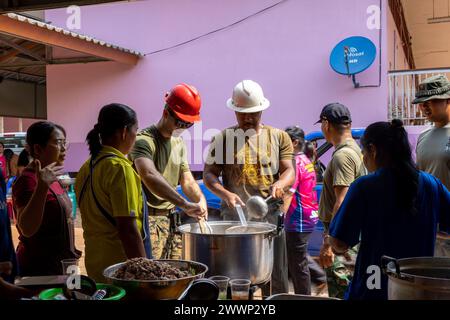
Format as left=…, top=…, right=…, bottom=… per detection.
left=412, top=74, right=450, bottom=104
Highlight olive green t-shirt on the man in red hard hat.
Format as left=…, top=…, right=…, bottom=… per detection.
left=129, top=125, right=189, bottom=210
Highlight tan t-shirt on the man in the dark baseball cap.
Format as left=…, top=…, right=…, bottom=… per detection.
left=319, top=139, right=366, bottom=223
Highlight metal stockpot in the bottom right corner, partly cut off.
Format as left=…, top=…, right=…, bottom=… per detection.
left=381, top=256, right=450, bottom=300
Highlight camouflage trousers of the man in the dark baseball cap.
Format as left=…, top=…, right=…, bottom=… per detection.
left=325, top=246, right=359, bottom=299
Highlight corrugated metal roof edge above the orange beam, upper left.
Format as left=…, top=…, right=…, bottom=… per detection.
left=4, top=13, right=144, bottom=57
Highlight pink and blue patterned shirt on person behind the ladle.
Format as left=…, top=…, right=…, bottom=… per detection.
left=284, top=153, right=318, bottom=232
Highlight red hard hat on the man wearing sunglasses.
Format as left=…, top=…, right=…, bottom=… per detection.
left=165, top=83, right=202, bottom=122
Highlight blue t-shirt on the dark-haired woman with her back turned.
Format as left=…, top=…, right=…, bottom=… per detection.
left=330, top=169, right=450, bottom=300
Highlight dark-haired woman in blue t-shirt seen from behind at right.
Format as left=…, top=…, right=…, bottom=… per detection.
left=329, top=120, right=450, bottom=299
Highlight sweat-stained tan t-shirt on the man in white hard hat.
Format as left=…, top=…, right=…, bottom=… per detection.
left=207, top=126, right=293, bottom=215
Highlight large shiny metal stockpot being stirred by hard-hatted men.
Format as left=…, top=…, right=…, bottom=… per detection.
left=178, top=221, right=279, bottom=284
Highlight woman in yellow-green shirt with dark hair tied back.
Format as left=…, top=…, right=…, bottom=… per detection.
left=75, top=103, right=151, bottom=281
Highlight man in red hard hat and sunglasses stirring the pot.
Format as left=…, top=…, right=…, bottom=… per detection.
left=129, top=83, right=207, bottom=259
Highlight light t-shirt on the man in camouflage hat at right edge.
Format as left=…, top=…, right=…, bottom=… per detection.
left=416, top=123, right=450, bottom=190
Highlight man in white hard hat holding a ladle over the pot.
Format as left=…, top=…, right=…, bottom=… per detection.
left=203, top=80, right=295, bottom=295
